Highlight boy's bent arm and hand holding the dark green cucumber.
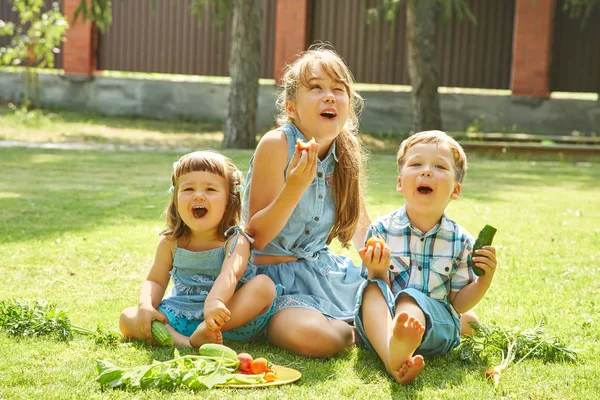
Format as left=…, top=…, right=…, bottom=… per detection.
left=450, top=246, right=496, bottom=313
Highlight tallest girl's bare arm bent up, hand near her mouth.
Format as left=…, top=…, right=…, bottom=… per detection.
left=247, top=130, right=318, bottom=250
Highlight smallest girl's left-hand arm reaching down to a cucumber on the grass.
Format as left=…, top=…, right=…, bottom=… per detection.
left=136, top=237, right=175, bottom=339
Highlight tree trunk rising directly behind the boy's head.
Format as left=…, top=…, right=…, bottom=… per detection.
left=406, top=0, right=442, bottom=132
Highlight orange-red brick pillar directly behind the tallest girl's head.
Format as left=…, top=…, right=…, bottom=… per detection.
left=273, top=0, right=309, bottom=82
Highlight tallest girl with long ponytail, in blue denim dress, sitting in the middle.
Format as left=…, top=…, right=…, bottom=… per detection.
left=244, top=47, right=369, bottom=357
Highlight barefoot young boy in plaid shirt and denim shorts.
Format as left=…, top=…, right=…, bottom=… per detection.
left=355, top=131, right=496, bottom=384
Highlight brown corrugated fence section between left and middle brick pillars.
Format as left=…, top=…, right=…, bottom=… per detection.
left=98, top=0, right=276, bottom=78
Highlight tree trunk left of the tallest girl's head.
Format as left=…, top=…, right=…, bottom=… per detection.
left=223, top=0, right=262, bottom=149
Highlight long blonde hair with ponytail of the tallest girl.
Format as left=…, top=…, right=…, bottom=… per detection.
left=276, top=44, right=365, bottom=247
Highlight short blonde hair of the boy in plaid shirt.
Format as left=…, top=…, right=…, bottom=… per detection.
left=396, top=131, right=467, bottom=183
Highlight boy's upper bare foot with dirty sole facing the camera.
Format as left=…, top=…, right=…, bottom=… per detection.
left=389, top=311, right=425, bottom=372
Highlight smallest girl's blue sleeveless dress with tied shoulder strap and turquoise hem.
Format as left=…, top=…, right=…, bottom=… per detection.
left=158, top=226, right=281, bottom=341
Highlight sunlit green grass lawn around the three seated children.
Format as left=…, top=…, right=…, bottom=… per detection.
left=0, top=109, right=600, bottom=400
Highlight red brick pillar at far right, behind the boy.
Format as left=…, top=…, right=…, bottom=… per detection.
left=511, top=0, right=556, bottom=97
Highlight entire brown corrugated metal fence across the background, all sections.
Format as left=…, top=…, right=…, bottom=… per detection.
left=0, top=0, right=600, bottom=92
